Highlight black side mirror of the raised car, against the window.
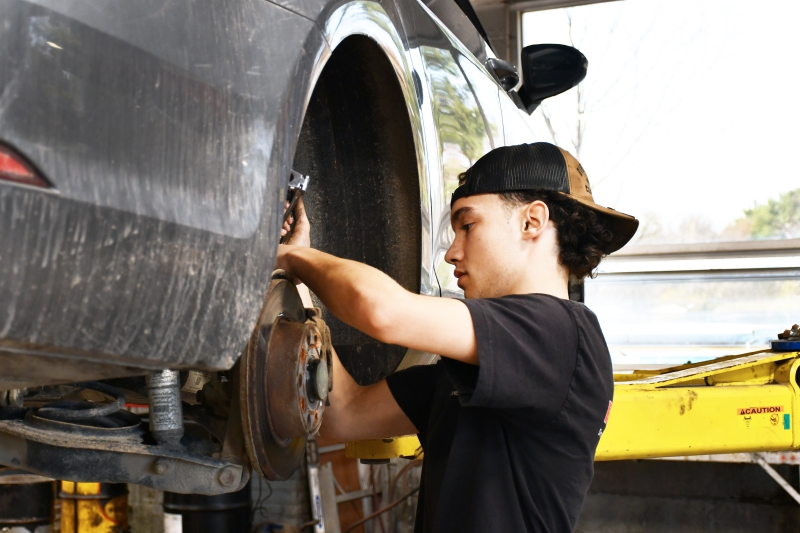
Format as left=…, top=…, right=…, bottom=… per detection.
left=519, top=44, right=589, bottom=114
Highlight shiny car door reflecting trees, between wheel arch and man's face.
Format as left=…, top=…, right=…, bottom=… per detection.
left=402, top=0, right=505, bottom=297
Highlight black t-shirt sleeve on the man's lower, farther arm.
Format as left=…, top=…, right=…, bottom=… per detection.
left=386, top=364, right=442, bottom=433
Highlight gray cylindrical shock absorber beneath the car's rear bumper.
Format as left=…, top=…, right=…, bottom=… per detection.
left=147, top=370, right=183, bottom=444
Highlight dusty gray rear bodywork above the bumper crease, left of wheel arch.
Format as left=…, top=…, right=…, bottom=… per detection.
left=0, top=0, right=313, bottom=238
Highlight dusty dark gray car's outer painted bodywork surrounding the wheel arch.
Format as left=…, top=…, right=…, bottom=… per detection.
left=0, top=0, right=536, bottom=389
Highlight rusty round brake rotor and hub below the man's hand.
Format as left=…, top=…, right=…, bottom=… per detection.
left=240, top=276, right=330, bottom=480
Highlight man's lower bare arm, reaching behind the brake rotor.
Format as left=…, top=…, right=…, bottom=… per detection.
left=320, top=344, right=417, bottom=442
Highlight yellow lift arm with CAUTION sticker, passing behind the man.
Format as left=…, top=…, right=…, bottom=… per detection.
left=346, top=350, right=800, bottom=461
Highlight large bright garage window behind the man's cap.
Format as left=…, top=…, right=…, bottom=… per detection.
left=522, top=0, right=800, bottom=369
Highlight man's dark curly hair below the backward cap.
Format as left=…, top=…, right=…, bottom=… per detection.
left=498, top=190, right=613, bottom=280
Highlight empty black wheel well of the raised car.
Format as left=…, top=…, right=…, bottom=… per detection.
left=294, top=36, right=422, bottom=384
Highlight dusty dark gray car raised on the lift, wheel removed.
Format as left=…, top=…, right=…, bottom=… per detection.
left=0, top=0, right=585, bottom=494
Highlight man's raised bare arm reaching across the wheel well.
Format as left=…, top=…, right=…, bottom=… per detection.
left=276, top=245, right=478, bottom=366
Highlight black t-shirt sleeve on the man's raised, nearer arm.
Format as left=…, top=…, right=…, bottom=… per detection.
left=442, top=295, right=578, bottom=420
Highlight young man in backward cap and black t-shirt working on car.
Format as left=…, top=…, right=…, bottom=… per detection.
left=277, top=143, right=638, bottom=533
